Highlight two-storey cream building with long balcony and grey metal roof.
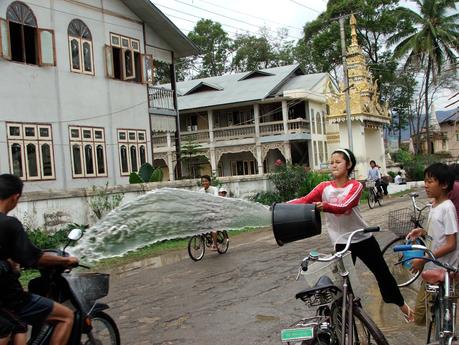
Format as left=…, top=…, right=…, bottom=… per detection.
left=153, top=65, right=335, bottom=179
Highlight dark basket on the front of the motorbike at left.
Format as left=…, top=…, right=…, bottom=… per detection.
left=62, top=273, right=110, bottom=313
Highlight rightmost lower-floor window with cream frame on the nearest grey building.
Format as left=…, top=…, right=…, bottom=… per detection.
left=116, top=128, right=149, bottom=176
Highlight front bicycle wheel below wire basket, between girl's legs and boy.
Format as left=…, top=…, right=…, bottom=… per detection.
left=382, top=237, right=424, bottom=287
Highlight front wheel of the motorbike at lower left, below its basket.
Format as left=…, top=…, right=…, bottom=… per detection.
left=81, top=311, right=121, bottom=345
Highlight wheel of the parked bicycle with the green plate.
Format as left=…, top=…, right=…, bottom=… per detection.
left=331, top=300, right=389, bottom=345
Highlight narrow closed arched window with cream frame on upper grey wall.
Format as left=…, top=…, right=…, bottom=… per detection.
left=67, top=19, right=94, bottom=74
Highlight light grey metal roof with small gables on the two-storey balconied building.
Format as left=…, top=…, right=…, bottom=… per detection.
left=169, top=64, right=327, bottom=110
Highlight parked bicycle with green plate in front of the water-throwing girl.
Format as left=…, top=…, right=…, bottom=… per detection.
left=281, top=227, right=388, bottom=345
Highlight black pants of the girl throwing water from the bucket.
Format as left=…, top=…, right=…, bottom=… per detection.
left=335, top=236, right=405, bottom=307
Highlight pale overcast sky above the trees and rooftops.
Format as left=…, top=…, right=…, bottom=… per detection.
left=150, top=0, right=452, bottom=110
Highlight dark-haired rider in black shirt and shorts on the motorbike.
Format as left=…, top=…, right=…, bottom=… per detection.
left=0, top=174, right=78, bottom=345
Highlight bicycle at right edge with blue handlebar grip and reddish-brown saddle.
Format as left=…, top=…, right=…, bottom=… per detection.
left=394, top=245, right=459, bottom=345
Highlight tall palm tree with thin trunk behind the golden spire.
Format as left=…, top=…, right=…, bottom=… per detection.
left=388, top=0, right=459, bottom=153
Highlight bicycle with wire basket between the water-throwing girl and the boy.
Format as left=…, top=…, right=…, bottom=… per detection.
left=382, top=193, right=430, bottom=287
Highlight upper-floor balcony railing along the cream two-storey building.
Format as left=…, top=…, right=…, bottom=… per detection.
left=152, top=119, right=310, bottom=147
